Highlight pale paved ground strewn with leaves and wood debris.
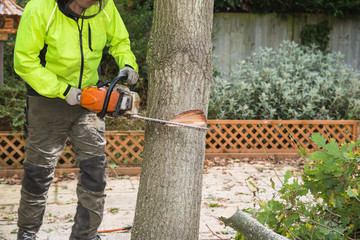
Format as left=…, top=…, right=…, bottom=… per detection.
left=0, top=159, right=298, bottom=240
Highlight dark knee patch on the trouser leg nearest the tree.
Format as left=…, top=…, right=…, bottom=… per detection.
left=79, top=156, right=106, bottom=192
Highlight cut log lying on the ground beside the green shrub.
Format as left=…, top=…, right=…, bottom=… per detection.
left=219, top=209, right=288, bottom=240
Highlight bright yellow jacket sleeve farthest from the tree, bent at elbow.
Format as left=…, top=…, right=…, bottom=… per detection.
left=14, top=1, right=69, bottom=99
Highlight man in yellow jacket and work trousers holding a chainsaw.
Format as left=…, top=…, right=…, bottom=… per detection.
left=14, top=0, right=138, bottom=239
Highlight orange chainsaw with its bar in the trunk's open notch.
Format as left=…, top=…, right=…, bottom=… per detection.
left=79, top=75, right=208, bottom=130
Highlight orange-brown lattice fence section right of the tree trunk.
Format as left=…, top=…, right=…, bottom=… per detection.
left=206, top=120, right=358, bottom=156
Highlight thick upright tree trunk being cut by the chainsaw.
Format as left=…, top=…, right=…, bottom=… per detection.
left=132, top=0, right=214, bottom=240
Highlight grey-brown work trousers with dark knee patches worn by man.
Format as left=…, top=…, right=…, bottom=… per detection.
left=18, top=96, right=106, bottom=239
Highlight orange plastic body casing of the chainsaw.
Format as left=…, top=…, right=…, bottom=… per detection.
left=80, top=86, right=120, bottom=113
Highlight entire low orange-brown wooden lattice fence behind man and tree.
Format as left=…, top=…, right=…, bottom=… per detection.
left=0, top=120, right=359, bottom=169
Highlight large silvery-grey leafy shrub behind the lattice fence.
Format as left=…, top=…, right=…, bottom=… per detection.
left=209, top=41, right=360, bottom=120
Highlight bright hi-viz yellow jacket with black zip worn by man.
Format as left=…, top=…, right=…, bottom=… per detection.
left=14, top=0, right=138, bottom=99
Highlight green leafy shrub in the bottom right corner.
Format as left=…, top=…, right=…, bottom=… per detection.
left=257, top=133, right=360, bottom=240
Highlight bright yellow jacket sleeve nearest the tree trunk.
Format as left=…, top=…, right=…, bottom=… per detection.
left=106, top=0, right=138, bottom=71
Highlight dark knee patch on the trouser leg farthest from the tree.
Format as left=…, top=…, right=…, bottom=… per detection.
left=22, top=162, right=54, bottom=194
